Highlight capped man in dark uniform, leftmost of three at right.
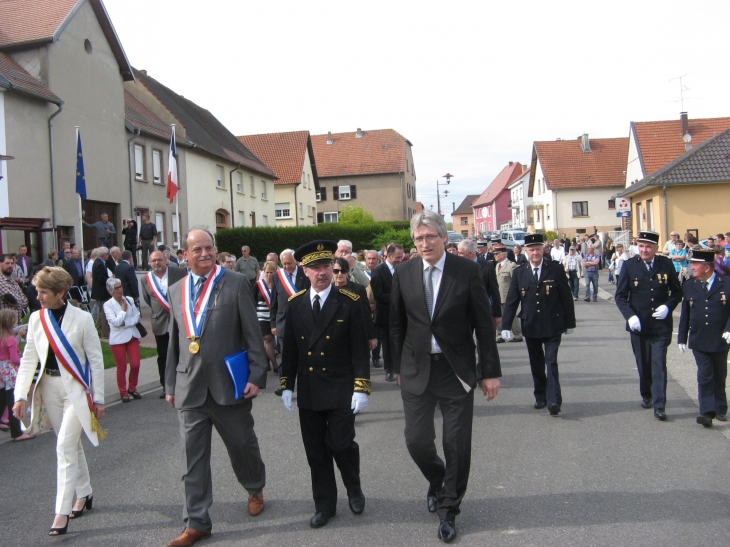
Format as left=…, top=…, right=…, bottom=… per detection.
left=502, top=234, right=575, bottom=416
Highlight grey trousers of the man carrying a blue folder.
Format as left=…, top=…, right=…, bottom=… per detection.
left=178, top=394, right=266, bottom=532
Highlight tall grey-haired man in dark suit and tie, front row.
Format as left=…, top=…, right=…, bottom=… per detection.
left=390, top=210, right=502, bottom=543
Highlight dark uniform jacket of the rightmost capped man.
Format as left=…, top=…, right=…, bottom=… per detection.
left=672, top=274, right=730, bottom=353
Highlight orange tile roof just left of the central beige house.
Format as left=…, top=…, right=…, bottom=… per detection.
left=238, top=131, right=313, bottom=184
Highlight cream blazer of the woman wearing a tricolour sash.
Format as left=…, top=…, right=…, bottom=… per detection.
left=15, top=304, right=104, bottom=446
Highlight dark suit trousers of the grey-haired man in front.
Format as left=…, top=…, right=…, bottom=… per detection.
left=401, top=355, right=474, bottom=520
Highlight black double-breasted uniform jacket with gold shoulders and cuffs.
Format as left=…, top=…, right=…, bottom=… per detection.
left=281, top=287, right=370, bottom=410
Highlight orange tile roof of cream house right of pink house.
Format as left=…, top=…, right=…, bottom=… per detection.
left=528, top=137, right=629, bottom=196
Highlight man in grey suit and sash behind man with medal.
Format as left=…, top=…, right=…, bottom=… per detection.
left=141, top=251, right=185, bottom=399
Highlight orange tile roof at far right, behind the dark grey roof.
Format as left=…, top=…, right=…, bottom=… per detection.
left=631, top=118, right=730, bottom=177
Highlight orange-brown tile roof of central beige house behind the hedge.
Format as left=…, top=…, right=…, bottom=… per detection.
left=312, top=129, right=412, bottom=177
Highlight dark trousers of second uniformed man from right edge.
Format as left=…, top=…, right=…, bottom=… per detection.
left=631, top=332, right=672, bottom=410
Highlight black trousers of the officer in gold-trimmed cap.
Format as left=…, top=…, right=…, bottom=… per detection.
left=299, top=408, right=362, bottom=515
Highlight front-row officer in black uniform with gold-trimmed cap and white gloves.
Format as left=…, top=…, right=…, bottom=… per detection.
left=281, top=240, right=370, bottom=528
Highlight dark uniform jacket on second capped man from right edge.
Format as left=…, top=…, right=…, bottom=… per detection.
left=615, top=255, right=682, bottom=336
